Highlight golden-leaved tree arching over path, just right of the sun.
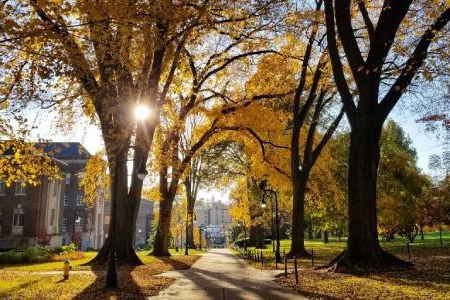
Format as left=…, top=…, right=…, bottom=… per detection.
left=149, top=1, right=286, bottom=256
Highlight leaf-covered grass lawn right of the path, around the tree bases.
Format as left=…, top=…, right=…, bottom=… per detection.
left=236, top=232, right=450, bottom=299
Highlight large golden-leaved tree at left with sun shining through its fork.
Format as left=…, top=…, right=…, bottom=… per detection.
left=0, top=0, right=284, bottom=264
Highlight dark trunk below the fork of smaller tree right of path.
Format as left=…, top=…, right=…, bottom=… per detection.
left=288, top=170, right=310, bottom=257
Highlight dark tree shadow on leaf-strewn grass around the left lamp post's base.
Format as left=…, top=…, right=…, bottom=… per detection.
left=73, top=265, right=146, bottom=300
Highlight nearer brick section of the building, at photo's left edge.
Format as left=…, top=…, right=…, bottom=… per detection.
left=0, top=160, right=67, bottom=249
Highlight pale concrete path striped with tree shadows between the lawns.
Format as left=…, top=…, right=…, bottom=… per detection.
left=150, top=249, right=307, bottom=300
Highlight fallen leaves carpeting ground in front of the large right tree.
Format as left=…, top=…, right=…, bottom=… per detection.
left=276, top=247, right=450, bottom=299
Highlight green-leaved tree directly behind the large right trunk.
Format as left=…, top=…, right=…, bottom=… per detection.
left=377, top=120, right=430, bottom=243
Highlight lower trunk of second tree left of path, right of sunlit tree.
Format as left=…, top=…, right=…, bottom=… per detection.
left=152, top=195, right=174, bottom=256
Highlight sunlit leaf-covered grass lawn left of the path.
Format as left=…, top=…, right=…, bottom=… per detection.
left=0, top=250, right=204, bottom=299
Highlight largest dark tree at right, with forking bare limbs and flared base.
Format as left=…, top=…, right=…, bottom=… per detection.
left=325, top=0, right=450, bottom=272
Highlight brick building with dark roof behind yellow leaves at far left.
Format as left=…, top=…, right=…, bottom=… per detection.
left=0, top=143, right=105, bottom=250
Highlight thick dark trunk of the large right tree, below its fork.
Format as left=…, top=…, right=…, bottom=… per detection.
left=330, top=119, right=408, bottom=272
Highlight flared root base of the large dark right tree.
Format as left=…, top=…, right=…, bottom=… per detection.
left=317, top=249, right=414, bottom=274
